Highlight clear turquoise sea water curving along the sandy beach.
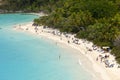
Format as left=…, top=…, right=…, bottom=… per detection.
left=0, top=14, right=92, bottom=80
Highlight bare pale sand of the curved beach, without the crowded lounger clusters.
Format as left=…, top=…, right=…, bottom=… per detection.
left=14, top=22, right=120, bottom=80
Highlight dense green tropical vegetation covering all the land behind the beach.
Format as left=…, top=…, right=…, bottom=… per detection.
left=1, top=0, right=120, bottom=63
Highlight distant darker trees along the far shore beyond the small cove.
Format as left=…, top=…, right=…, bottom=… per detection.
left=1, top=0, right=57, bottom=12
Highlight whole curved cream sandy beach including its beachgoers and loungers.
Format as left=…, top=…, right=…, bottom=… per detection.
left=13, top=22, right=120, bottom=80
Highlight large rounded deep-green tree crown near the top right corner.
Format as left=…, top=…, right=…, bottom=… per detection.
left=86, top=0, right=118, bottom=19
